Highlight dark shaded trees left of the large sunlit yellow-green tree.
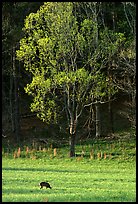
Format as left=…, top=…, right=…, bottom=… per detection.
left=2, top=2, right=42, bottom=142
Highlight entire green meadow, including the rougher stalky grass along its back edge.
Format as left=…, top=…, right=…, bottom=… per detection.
left=2, top=136, right=136, bottom=202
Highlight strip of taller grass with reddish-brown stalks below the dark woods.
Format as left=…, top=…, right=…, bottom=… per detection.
left=2, top=135, right=136, bottom=160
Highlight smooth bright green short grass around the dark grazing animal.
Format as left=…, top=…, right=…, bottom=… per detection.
left=2, top=157, right=136, bottom=202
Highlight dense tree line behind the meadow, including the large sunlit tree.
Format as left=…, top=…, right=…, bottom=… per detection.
left=2, top=2, right=136, bottom=156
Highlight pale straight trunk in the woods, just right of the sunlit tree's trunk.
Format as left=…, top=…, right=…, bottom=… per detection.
left=95, top=103, right=101, bottom=137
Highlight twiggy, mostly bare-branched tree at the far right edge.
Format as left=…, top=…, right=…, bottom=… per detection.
left=114, top=2, right=136, bottom=128
